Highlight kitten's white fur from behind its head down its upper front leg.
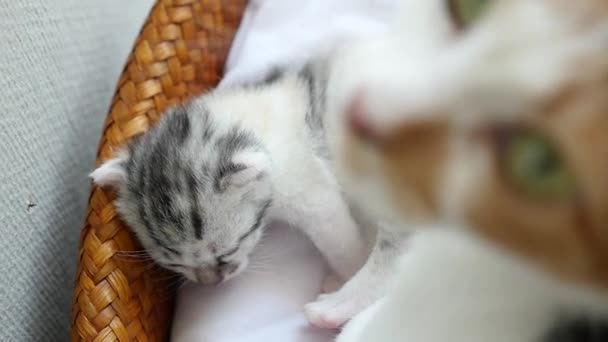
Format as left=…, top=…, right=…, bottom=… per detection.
left=206, top=75, right=367, bottom=278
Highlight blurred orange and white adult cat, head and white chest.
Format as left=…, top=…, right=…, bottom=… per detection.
left=328, top=0, right=608, bottom=342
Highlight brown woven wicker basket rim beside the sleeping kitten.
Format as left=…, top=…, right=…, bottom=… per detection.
left=71, top=0, right=246, bottom=341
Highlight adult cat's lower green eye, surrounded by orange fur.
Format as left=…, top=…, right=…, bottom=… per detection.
left=503, top=132, right=574, bottom=199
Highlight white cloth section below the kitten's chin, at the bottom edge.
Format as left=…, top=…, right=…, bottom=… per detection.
left=172, top=225, right=334, bottom=342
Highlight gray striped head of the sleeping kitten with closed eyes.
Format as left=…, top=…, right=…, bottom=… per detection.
left=91, top=103, right=272, bottom=284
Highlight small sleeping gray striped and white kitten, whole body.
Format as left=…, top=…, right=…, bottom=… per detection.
left=91, top=62, right=401, bottom=328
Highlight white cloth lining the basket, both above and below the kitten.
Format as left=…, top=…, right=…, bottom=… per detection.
left=172, top=0, right=398, bottom=342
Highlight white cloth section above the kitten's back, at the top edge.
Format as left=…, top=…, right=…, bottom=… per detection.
left=220, top=0, right=399, bottom=87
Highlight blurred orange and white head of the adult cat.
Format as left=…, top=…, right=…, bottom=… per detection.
left=334, top=0, right=608, bottom=288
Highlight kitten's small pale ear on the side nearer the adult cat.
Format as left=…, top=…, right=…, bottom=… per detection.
left=215, top=151, right=270, bottom=190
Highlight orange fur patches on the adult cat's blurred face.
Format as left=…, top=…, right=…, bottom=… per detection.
left=349, top=82, right=608, bottom=289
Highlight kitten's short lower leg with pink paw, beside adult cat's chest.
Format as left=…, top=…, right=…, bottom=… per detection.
left=304, top=224, right=406, bottom=328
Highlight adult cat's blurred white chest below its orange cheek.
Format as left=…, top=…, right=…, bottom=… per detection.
left=337, top=230, right=608, bottom=342
